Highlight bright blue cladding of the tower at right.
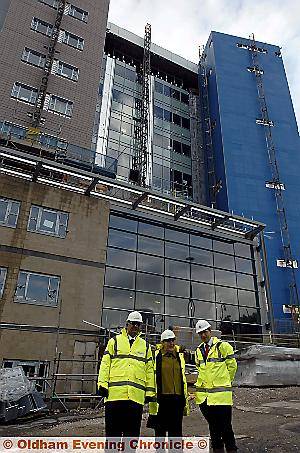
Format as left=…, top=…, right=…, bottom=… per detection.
left=206, top=32, right=300, bottom=328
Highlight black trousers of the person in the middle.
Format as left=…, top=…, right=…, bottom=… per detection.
left=155, top=395, right=185, bottom=437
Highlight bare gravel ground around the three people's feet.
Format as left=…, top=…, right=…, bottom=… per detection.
left=0, top=387, right=300, bottom=453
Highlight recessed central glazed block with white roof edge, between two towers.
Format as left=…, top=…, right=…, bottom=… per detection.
left=93, top=23, right=206, bottom=204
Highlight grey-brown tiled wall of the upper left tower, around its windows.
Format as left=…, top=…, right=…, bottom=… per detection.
left=0, top=0, right=109, bottom=148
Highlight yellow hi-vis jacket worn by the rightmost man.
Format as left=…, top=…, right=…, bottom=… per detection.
left=195, top=337, right=237, bottom=406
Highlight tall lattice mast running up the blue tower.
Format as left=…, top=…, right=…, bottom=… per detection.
left=248, top=34, right=299, bottom=328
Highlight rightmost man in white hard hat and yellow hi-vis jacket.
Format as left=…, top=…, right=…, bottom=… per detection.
left=195, top=319, right=237, bottom=453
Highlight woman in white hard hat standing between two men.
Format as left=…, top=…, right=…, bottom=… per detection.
left=147, top=329, right=189, bottom=438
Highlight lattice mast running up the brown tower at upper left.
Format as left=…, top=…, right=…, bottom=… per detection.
left=32, top=0, right=66, bottom=128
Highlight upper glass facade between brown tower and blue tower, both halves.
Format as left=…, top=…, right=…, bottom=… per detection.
left=94, top=55, right=193, bottom=199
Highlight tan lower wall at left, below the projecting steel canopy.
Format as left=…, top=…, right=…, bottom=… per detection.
left=0, top=175, right=109, bottom=388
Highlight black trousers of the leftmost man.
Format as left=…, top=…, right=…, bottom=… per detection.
left=105, top=401, right=143, bottom=438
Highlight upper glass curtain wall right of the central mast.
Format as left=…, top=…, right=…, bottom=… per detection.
left=152, top=78, right=193, bottom=199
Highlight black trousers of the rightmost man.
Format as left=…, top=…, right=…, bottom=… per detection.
left=200, top=400, right=237, bottom=451
